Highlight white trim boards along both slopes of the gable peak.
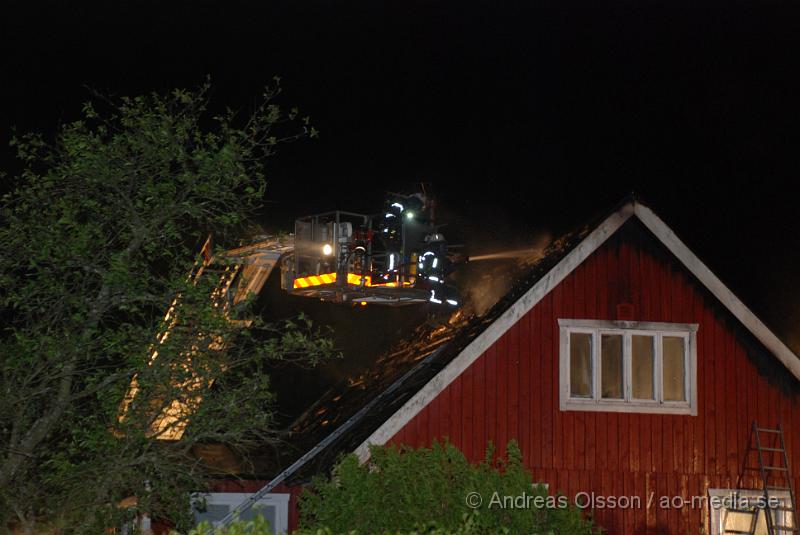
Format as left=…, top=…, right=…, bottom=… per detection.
left=355, top=201, right=800, bottom=461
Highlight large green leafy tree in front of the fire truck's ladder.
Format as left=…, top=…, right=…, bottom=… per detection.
left=0, top=79, right=331, bottom=533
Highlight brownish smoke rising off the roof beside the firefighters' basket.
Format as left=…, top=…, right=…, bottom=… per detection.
left=451, top=232, right=552, bottom=316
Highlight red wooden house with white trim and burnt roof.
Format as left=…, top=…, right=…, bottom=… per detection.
left=181, top=200, right=800, bottom=535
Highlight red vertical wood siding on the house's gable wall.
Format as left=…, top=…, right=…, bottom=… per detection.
left=390, top=221, right=800, bottom=535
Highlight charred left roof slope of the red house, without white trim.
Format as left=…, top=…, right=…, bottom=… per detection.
left=256, top=213, right=593, bottom=484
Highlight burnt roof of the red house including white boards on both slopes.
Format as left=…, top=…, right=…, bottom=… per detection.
left=230, top=198, right=800, bottom=485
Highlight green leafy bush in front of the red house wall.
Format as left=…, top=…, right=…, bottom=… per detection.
left=300, top=441, right=596, bottom=535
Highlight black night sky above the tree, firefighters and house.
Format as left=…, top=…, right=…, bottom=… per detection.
left=0, top=0, right=800, bottom=349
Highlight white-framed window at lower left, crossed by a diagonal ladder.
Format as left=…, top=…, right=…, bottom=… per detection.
left=194, top=492, right=289, bottom=535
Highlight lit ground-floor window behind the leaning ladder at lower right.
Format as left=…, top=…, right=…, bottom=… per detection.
left=708, top=489, right=793, bottom=535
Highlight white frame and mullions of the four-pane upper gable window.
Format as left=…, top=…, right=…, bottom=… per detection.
left=558, top=318, right=698, bottom=416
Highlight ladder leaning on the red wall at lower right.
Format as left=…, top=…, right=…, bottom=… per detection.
left=725, top=422, right=800, bottom=535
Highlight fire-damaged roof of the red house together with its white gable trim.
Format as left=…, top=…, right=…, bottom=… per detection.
left=225, top=200, right=800, bottom=511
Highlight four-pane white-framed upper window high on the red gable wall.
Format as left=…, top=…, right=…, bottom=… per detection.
left=558, top=319, right=697, bottom=415
